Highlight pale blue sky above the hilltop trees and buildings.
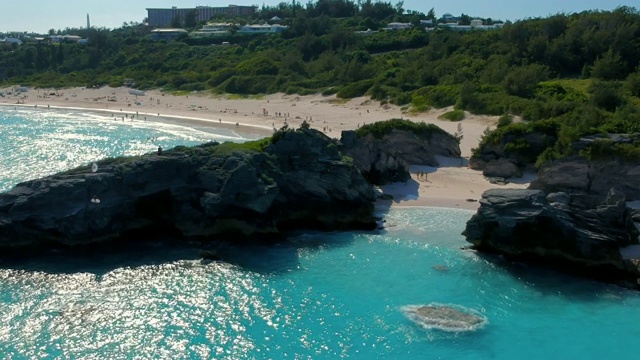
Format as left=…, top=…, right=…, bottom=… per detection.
left=0, top=0, right=640, bottom=33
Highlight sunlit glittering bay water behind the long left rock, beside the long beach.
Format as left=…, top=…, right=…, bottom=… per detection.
left=0, top=108, right=255, bottom=192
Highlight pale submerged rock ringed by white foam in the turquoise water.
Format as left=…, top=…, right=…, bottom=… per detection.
left=401, top=303, right=487, bottom=332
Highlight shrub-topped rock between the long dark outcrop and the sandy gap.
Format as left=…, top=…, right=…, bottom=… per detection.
left=340, top=124, right=460, bottom=185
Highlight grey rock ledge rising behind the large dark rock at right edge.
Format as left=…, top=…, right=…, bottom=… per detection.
left=529, top=157, right=640, bottom=200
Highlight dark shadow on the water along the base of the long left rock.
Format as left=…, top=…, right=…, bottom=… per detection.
left=0, top=232, right=356, bottom=278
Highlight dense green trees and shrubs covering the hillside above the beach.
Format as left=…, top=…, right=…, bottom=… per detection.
left=0, top=0, right=640, bottom=165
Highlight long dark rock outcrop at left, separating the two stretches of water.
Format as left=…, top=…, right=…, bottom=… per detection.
left=0, top=129, right=376, bottom=249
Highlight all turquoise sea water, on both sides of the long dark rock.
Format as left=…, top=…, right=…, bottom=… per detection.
left=0, top=108, right=640, bottom=359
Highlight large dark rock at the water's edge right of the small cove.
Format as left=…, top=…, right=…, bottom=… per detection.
left=463, top=189, right=640, bottom=284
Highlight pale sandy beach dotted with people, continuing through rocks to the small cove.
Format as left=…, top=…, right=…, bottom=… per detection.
left=0, top=87, right=532, bottom=210
